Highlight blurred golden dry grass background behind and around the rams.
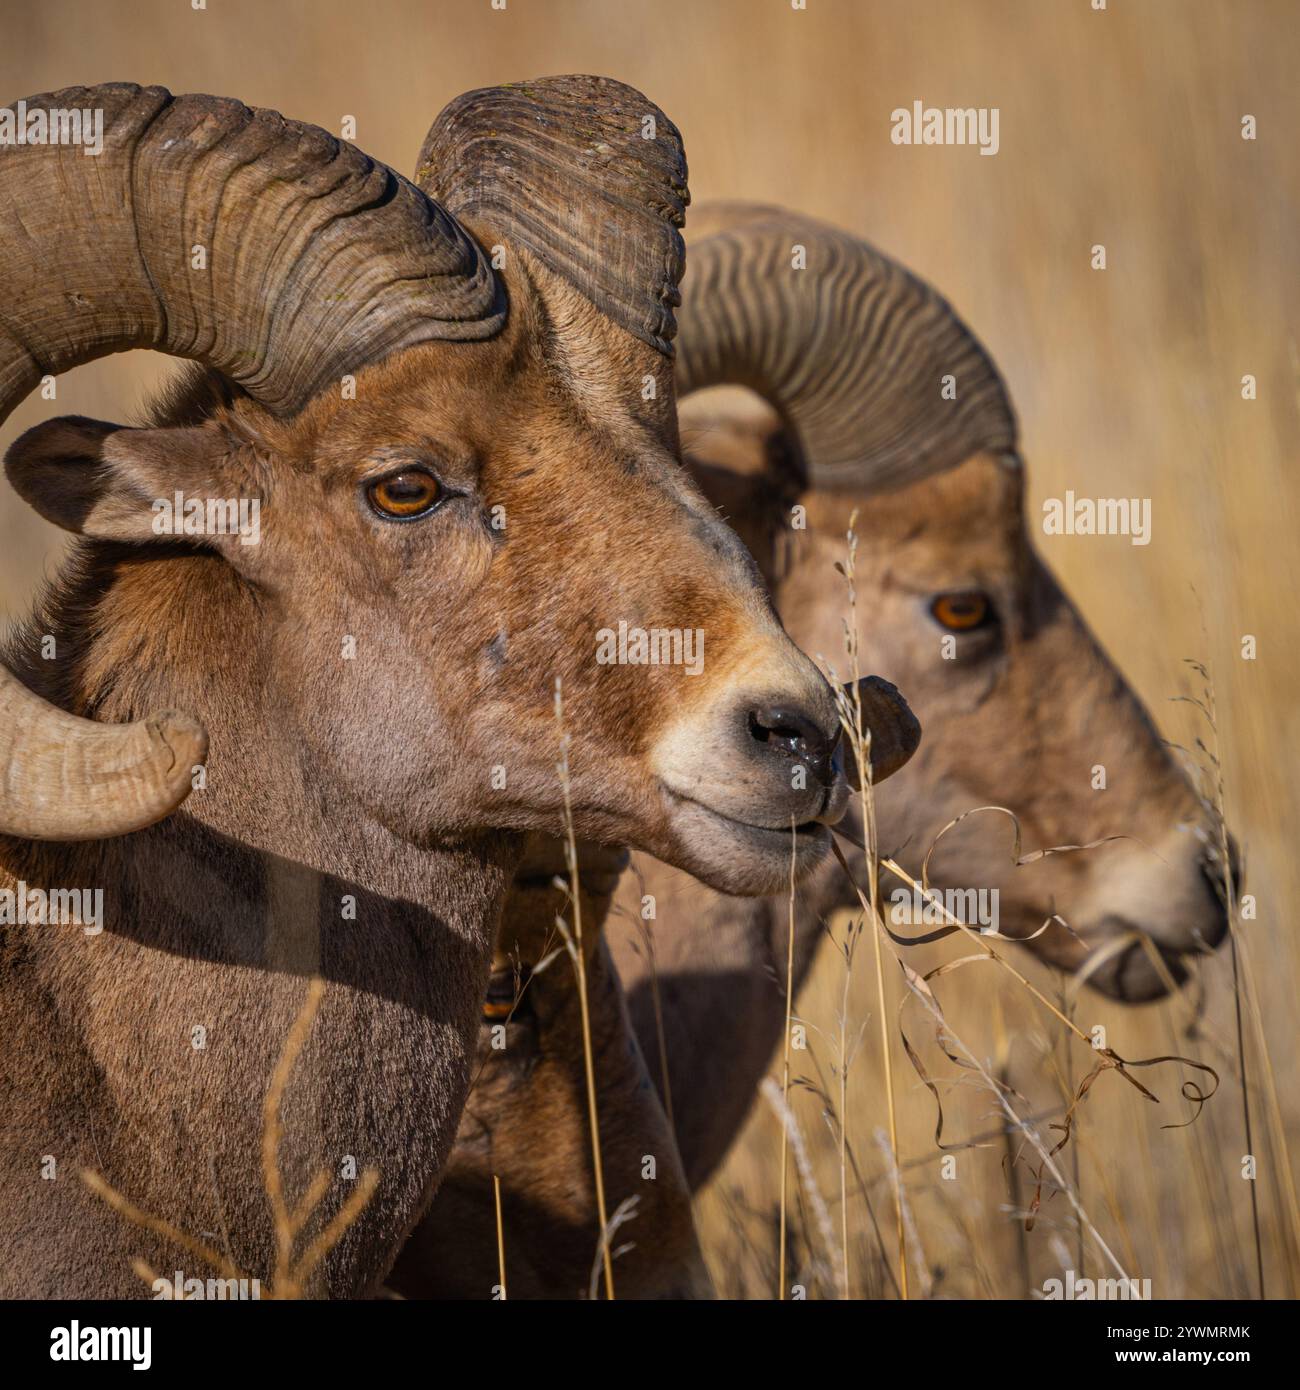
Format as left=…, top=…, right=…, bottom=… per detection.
left=0, top=0, right=1300, bottom=1297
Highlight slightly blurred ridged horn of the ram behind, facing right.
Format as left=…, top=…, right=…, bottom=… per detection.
left=676, top=203, right=1016, bottom=489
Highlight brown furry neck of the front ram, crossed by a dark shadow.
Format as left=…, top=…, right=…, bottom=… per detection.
left=0, top=544, right=519, bottom=1297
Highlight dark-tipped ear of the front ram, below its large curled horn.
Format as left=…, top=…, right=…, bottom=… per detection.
left=4, top=416, right=254, bottom=546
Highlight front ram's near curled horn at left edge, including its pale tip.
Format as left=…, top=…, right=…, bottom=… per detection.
left=0, top=83, right=505, bottom=840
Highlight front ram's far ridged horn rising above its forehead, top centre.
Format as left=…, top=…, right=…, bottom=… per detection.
left=416, top=76, right=690, bottom=356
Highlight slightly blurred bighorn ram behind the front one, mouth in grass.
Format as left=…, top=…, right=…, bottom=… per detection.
left=610, top=204, right=1225, bottom=1187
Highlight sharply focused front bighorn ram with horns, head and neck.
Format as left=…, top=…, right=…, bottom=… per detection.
left=0, top=89, right=895, bottom=1295
